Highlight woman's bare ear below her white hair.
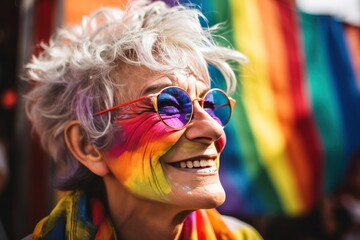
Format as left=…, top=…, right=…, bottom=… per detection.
left=64, top=120, right=109, bottom=176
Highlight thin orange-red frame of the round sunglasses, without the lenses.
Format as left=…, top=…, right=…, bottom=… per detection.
left=94, top=86, right=236, bottom=130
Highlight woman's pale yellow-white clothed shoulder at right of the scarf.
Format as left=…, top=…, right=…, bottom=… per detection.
left=221, top=215, right=263, bottom=240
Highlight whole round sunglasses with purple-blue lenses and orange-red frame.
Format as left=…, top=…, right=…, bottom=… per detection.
left=95, top=86, right=236, bottom=130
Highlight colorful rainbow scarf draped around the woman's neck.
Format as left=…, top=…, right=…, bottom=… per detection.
left=32, top=192, right=261, bottom=240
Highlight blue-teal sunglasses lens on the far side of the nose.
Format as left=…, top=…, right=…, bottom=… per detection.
left=204, top=89, right=231, bottom=126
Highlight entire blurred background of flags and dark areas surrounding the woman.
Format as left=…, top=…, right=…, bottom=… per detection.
left=0, top=0, right=360, bottom=239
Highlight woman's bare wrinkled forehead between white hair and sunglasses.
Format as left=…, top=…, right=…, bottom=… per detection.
left=118, top=65, right=210, bottom=99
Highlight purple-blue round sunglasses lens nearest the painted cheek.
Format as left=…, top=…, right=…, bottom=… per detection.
left=157, top=87, right=192, bottom=129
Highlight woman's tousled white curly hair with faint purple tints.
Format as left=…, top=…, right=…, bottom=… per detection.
left=24, top=0, right=246, bottom=190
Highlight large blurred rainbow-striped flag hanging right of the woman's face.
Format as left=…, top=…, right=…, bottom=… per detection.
left=167, top=0, right=360, bottom=215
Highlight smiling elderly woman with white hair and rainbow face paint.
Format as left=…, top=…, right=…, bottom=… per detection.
left=25, top=1, right=261, bottom=240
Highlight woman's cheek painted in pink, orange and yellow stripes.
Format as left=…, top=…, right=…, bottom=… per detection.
left=107, top=112, right=183, bottom=200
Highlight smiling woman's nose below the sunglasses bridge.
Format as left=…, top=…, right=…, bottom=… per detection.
left=185, top=100, right=225, bottom=145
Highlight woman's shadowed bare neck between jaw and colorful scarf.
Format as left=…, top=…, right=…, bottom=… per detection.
left=104, top=176, right=191, bottom=240
